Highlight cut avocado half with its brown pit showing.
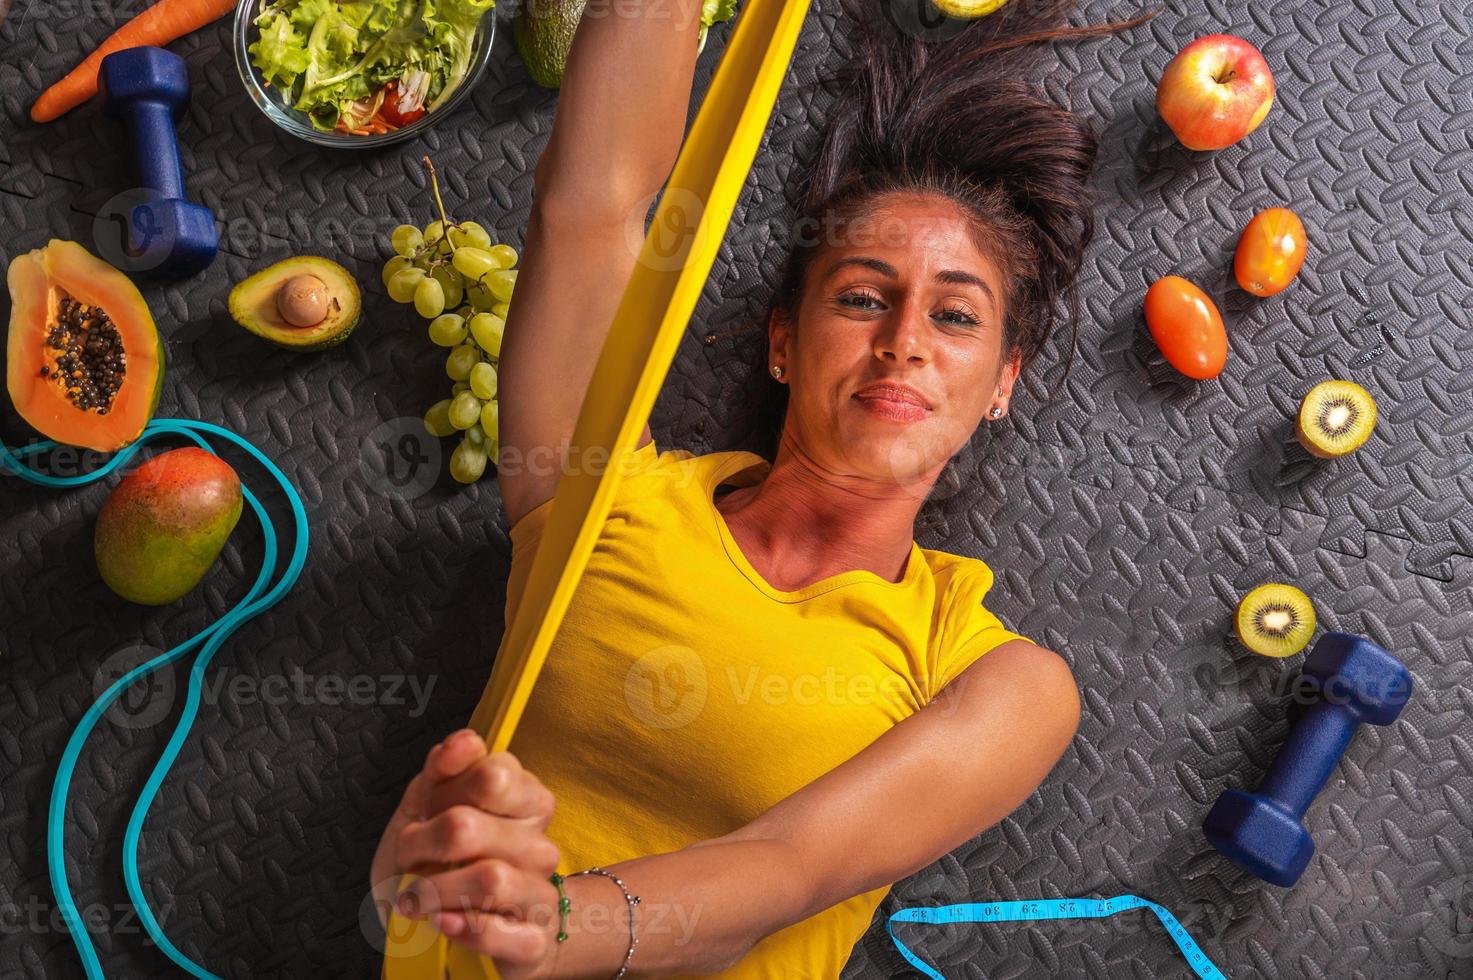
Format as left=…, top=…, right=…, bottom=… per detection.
left=230, top=255, right=362, bottom=351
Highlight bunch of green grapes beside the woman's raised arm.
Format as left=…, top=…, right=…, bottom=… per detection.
left=383, top=218, right=517, bottom=483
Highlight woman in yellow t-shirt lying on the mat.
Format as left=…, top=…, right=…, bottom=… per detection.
left=373, top=0, right=1134, bottom=980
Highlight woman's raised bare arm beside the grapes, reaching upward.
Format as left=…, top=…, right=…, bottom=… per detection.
left=496, top=0, right=701, bottom=523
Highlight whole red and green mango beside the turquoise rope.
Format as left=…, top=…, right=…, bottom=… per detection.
left=93, top=447, right=243, bottom=606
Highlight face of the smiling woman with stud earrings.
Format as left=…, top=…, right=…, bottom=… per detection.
left=769, top=193, right=1018, bottom=500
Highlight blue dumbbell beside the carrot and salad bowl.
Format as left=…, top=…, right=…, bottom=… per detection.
left=97, top=47, right=219, bottom=279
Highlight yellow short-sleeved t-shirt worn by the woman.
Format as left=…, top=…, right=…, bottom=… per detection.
left=448, top=444, right=1018, bottom=980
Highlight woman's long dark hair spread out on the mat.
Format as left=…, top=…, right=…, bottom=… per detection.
left=756, top=0, right=1155, bottom=457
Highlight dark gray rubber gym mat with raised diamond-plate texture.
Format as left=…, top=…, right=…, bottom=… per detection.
left=0, top=0, right=1473, bottom=980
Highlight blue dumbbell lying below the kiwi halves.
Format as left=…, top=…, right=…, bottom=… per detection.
left=1202, top=632, right=1411, bottom=887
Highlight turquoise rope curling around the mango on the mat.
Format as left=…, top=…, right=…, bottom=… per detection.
left=0, top=419, right=308, bottom=980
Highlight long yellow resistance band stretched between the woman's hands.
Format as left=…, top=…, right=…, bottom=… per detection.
left=383, top=0, right=809, bottom=980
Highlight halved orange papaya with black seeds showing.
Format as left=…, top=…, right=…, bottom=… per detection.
left=6, top=240, right=164, bottom=452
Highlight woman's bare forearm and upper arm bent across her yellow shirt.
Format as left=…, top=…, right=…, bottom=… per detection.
left=533, top=640, right=1080, bottom=977
